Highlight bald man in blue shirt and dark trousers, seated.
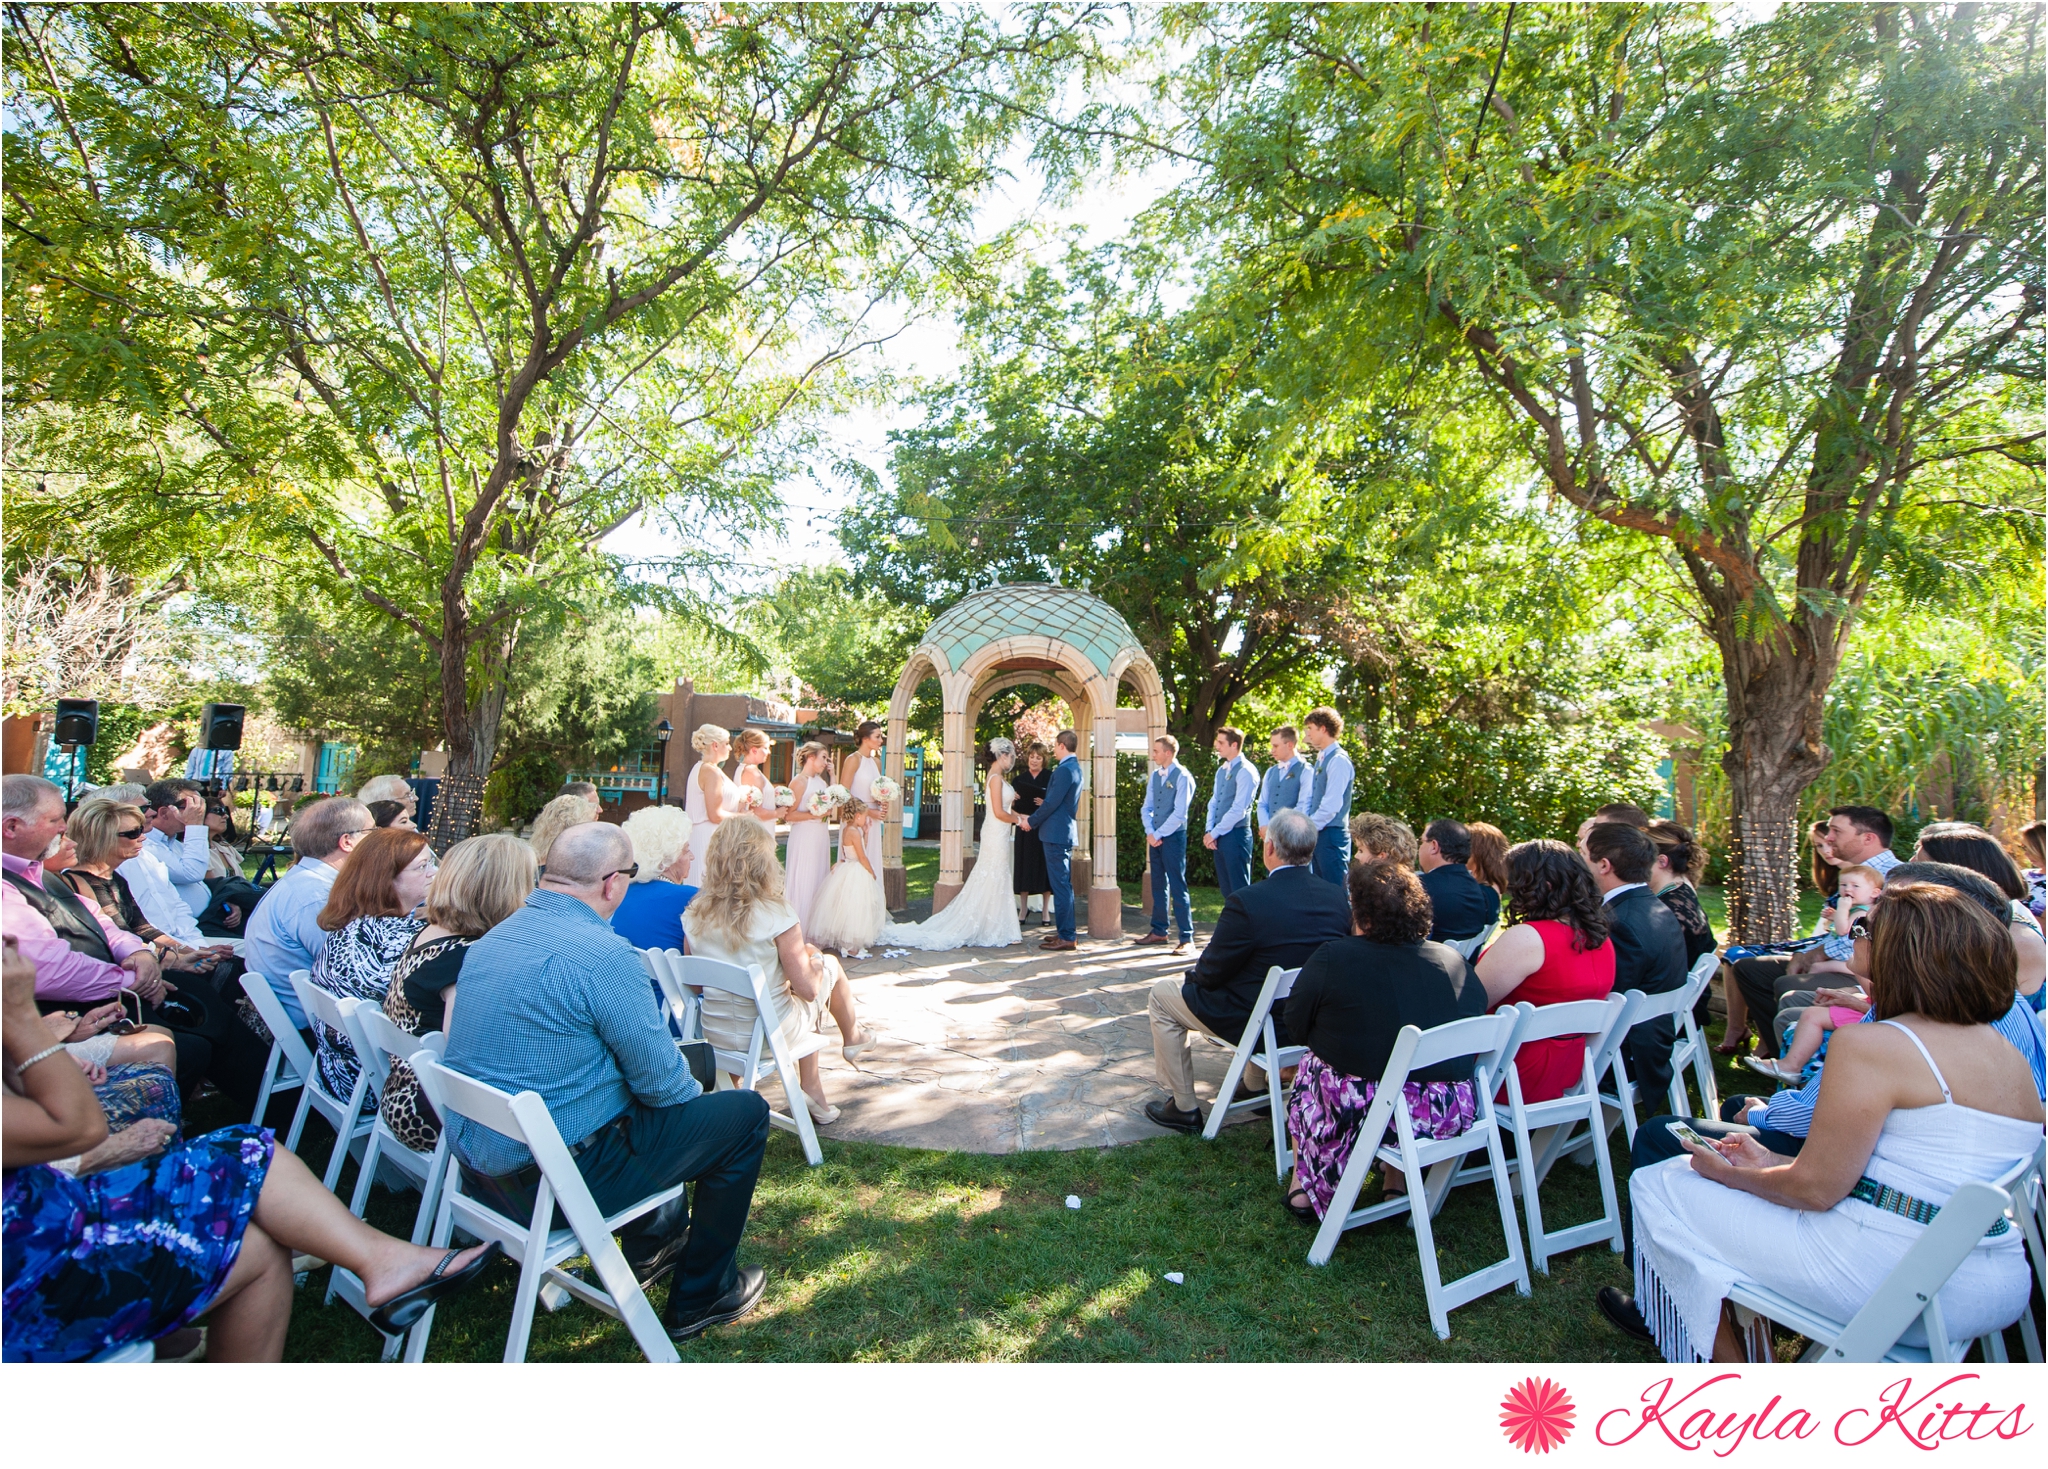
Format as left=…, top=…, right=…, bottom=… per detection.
left=446, top=822, right=774, bottom=1340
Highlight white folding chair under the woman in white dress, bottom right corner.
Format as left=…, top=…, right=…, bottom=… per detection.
left=1729, top=1143, right=2048, bottom=1362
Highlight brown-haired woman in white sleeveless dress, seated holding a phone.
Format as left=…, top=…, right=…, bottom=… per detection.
left=1599, top=879, right=2042, bottom=1362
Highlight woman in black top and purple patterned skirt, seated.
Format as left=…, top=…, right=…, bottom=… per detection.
left=1286, top=858, right=1487, bottom=1221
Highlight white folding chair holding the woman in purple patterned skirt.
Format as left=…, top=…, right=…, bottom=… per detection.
left=1309, top=1008, right=1530, bottom=1340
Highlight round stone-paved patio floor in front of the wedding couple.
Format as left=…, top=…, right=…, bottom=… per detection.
left=790, top=908, right=1264, bottom=1153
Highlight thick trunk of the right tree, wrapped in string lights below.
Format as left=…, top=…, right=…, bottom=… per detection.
left=1716, top=625, right=1839, bottom=942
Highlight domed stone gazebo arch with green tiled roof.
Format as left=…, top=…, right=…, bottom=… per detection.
left=883, top=582, right=1165, bottom=938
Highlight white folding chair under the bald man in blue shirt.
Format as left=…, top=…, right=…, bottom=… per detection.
left=406, top=1051, right=688, bottom=1362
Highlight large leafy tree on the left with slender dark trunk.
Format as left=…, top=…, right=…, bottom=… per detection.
left=4, top=4, right=1122, bottom=840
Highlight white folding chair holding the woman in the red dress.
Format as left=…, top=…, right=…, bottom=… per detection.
left=1501, top=992, right=1634, bottom=1274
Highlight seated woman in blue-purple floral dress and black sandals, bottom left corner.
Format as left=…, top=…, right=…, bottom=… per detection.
left=0, top=938, right=502, bottom=1362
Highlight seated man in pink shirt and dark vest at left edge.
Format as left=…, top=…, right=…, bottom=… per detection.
left=0, top=774, right=166, bottom=1006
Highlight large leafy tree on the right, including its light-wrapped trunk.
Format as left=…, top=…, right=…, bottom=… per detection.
left=1163, top=4, right=2044, bottom=938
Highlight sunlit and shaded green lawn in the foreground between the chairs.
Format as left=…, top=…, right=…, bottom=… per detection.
left=287, top=1098, right=1649, bottom=1362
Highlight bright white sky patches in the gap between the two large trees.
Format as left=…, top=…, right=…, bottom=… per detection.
left=604, top=160, right=1178, bottom=582
